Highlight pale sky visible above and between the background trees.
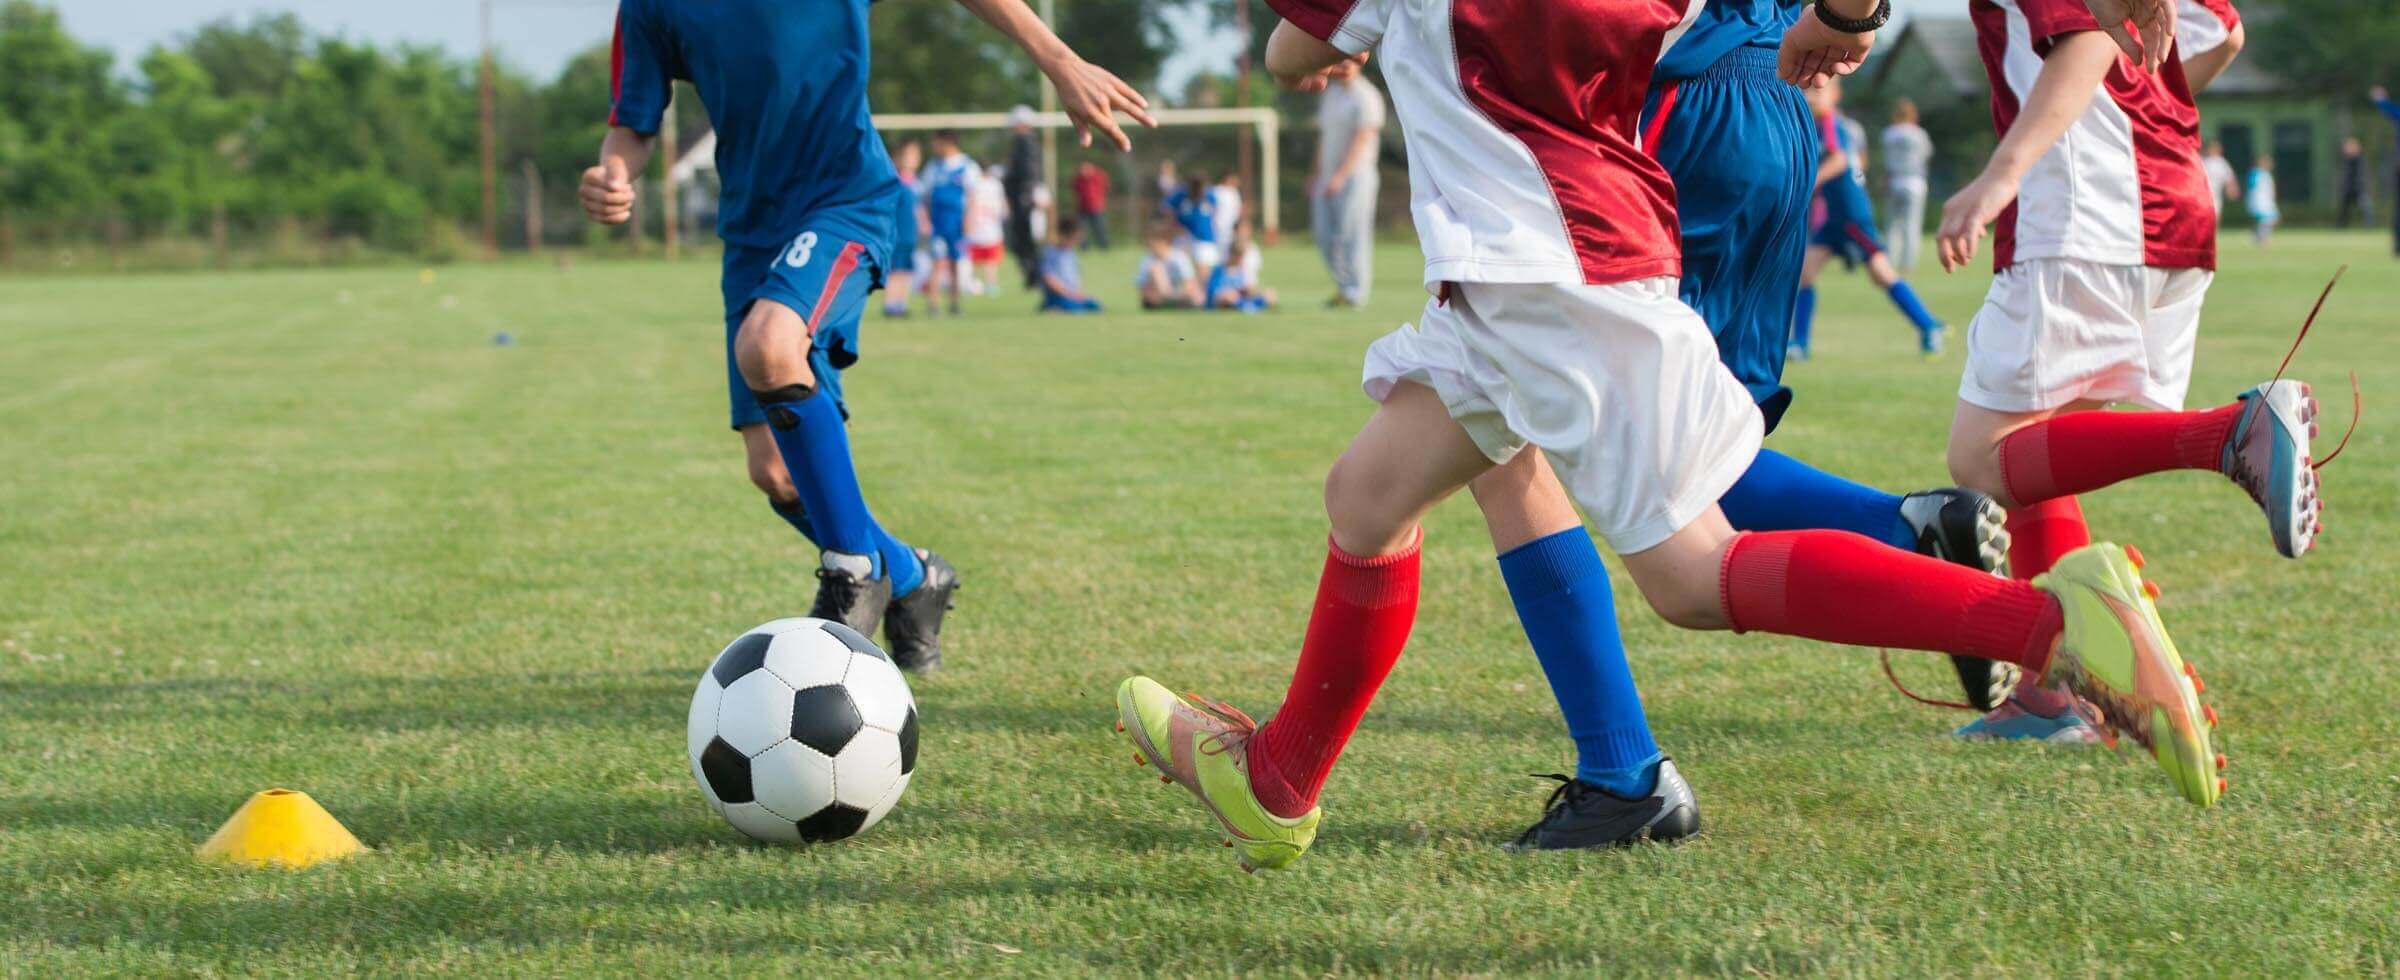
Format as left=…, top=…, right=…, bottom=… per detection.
left=65, top=0, right=1963, bottom=91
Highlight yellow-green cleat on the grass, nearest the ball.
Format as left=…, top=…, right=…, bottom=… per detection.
left=1116, top=677, right=1322, bottom=872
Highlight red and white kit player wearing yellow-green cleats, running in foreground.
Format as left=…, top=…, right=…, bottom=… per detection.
left=1118, top=0, right=2222, bottom=867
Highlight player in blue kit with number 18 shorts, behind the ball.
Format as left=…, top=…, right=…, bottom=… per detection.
left=581, top=0, right=1147, bottom=670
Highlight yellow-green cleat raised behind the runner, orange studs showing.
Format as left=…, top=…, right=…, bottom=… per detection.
left=2033, top=543, right=2225, bottom=807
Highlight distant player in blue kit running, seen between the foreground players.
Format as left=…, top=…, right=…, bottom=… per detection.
left=1790, top=82, right=1942, bottom=360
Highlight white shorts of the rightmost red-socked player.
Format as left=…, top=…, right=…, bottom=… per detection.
left=1958, top=259, right=2215, bottom=411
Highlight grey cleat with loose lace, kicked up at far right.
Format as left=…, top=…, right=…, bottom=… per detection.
left=2218, top=382, right=2326, bottom=557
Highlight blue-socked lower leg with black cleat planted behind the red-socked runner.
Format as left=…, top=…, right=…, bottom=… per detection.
left=1469, top=449, right=1699, bottom=850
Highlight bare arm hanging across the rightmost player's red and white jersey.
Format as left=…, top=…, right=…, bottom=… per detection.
left=1934, top=31, right=2117, bottom=269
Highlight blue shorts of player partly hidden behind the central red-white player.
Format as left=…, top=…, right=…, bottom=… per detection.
left=1642, top=48, right=1819, bottom=432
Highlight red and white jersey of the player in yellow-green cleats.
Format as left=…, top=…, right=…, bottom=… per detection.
left=1267, top=0, right=1699, bottom=286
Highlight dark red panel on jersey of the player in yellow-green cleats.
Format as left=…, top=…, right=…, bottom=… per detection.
left=1450, top=0, right=1690, bottom=286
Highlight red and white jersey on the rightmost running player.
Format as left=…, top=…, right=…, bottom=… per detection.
left=1968, top=0, right=2218, bottom=269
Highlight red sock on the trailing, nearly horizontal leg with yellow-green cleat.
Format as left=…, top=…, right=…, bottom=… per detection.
left=1718, top=531, right=2064, bottom=673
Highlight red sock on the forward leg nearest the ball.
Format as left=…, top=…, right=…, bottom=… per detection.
left=1248, top=533, right=1423, bottom=817
